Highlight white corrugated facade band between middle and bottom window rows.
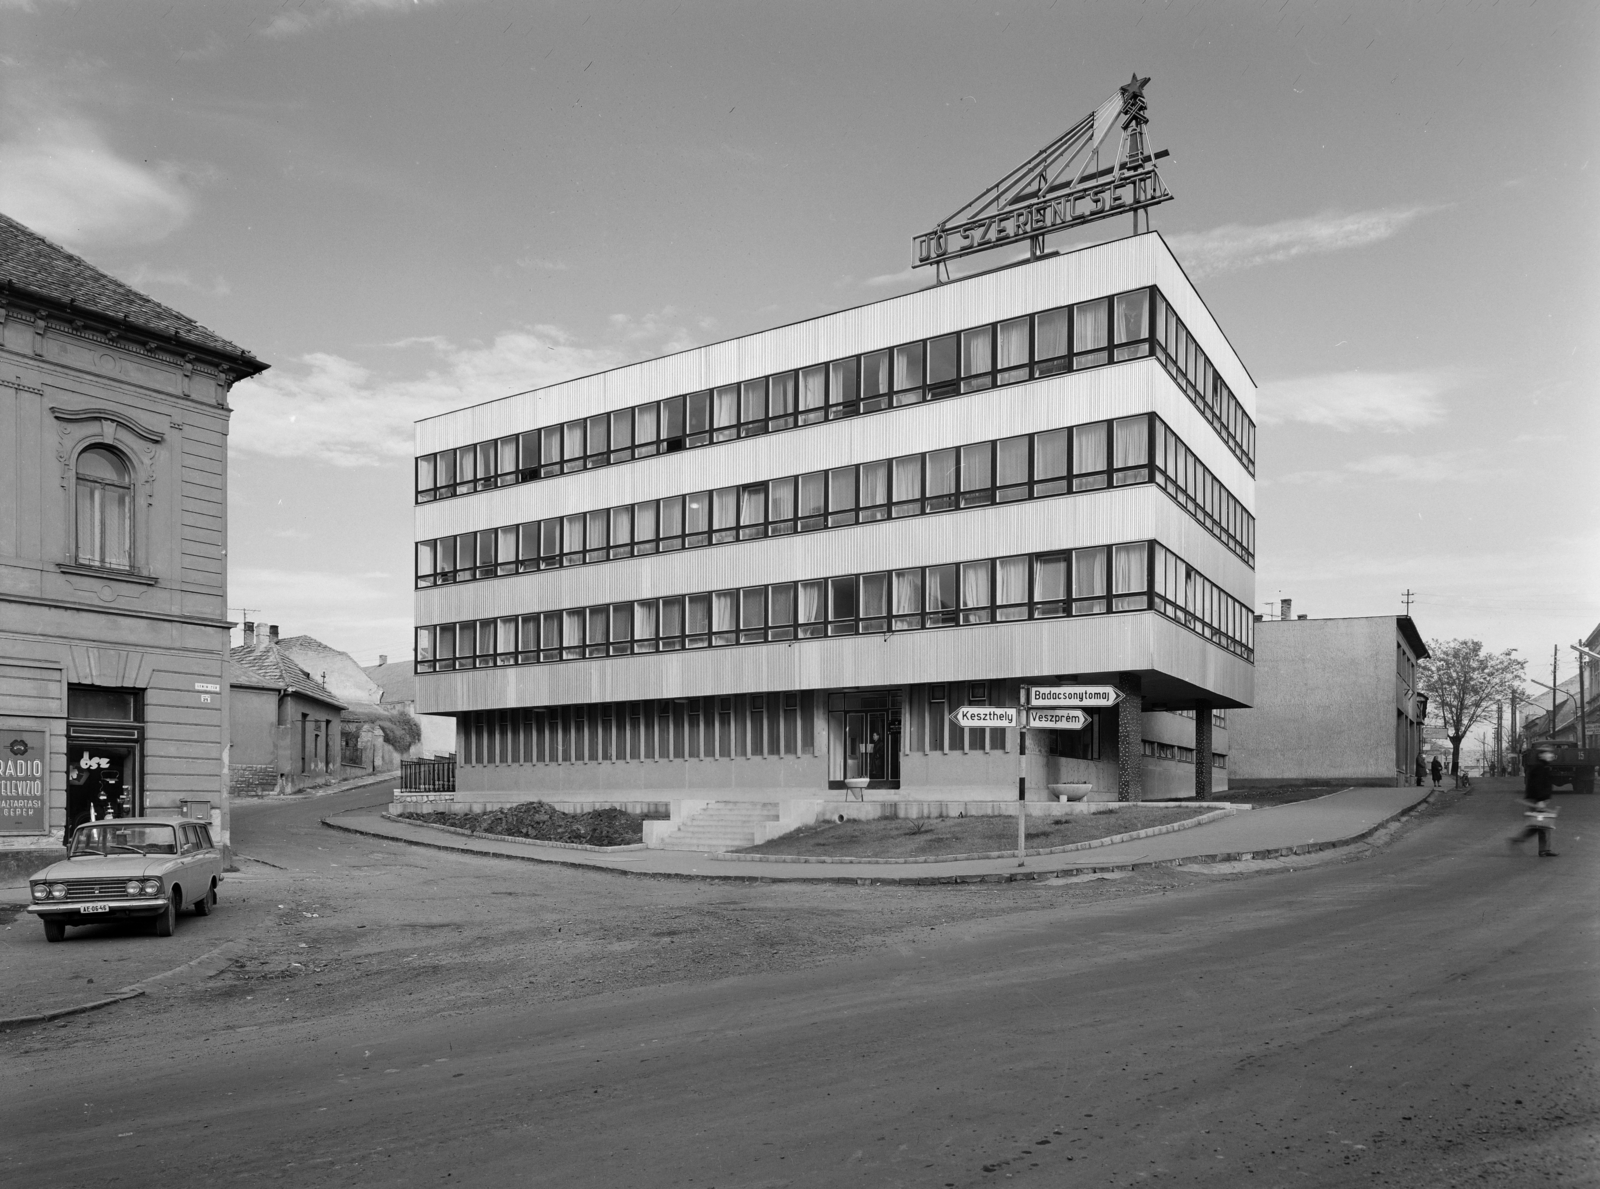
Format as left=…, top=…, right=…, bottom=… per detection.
left=418, top=486, right=1254, bottom=624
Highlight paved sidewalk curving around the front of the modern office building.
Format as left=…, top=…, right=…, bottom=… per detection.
left=323, top=787, right=1432, bottom=883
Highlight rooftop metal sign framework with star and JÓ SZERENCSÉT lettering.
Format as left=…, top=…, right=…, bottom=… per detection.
left=912, top=74, right=1173, bottom=282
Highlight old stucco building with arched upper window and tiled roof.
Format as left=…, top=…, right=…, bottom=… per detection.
left=0, top=216, right=266, bottom=869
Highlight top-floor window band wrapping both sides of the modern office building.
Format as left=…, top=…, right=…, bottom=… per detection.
left=416, top=286, right=1254, bottom=502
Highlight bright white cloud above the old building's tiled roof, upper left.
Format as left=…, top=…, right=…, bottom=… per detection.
left=0, top=106, right=195, bottom=248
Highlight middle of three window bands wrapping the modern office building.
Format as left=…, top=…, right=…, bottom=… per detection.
left=416, top=413, right=1256, bottom=587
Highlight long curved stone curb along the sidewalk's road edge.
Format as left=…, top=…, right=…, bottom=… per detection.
left=322, top=789, right=1442, bottom=887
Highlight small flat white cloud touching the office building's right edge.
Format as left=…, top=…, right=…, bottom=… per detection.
left=1258, top=370, right=1456, bottom=434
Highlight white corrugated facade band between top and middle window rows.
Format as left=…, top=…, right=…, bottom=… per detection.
left=416, top=360, right=1254, bottom=539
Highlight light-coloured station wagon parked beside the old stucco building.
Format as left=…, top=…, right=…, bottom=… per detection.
left=27, top=818, right=222, bottom=941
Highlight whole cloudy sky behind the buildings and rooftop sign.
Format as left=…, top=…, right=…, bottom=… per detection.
left=0, top=0, right=1600, bottom=697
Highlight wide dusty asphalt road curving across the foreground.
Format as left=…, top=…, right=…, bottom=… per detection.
left=0, top=780, right=1600, bottom=1189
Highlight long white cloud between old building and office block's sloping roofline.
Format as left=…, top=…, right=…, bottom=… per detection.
left=229, top=310, right=706, bottom=467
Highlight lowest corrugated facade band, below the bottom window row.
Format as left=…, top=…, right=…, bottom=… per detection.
left=418, top=611, right=1253, bottom=714
